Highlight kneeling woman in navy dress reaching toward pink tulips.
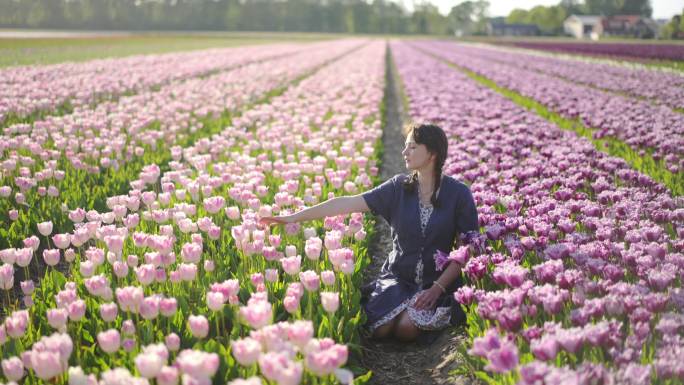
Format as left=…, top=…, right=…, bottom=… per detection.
left=261, top=124, right=478, bottom=341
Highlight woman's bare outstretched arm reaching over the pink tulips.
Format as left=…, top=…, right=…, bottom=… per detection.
left=260, top=194, right=369, bottom=225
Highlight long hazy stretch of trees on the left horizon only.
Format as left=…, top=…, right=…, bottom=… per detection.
left=0, top=0, right=449, bottom=34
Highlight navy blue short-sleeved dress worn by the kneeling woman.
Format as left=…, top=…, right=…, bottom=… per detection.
left=362, top=174, right=479, bottom=330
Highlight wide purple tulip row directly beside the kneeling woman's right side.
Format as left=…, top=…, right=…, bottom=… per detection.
left=392, top=44, right=684, bottom=384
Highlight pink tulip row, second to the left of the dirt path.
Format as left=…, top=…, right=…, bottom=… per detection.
left=0, top=40, right=361, bottom=247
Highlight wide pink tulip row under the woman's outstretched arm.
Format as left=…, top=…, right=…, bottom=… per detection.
left=0, top=42, right=385, bottom=385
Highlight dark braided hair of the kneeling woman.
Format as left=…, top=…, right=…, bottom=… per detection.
left=403, top=123, right=449, bottom=207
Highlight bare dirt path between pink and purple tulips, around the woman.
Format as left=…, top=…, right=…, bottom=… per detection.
left=361, top=43, right=473, bottom=385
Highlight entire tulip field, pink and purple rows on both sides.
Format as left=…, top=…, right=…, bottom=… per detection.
left=0, top=34, right=684, bottom=385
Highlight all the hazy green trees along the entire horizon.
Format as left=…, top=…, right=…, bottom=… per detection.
left=0, top=0, right=684, bottom=38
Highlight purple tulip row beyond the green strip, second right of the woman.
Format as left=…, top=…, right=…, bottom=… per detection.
left=408, top=42, right=684, bottom=179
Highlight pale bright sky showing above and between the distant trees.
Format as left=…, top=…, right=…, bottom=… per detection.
left=395, top=0, right=684, bottom=19
